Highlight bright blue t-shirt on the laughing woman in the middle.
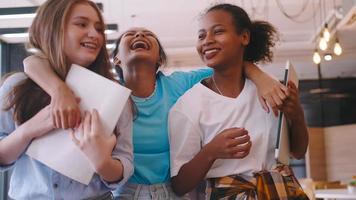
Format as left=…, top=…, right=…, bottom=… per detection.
left=129, top=69, right=213, bottom=184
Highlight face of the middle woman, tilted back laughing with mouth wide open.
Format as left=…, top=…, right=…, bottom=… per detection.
left=116, top=28, right=160, bottom=67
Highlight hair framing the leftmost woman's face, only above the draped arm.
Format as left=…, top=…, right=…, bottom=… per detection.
left=29, top=0, right=112, bottom=80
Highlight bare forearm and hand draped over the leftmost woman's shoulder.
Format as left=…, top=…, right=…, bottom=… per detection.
left=23, top=56, right=81, bottom=129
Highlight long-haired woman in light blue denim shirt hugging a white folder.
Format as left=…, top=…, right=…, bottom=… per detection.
left=0, top=0, right=133, bottom=199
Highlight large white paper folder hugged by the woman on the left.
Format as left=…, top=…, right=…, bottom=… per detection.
left=26, top=65, right=131, bottom=185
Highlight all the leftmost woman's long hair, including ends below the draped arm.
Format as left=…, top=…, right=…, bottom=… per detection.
left=5, top=0, right=113, bottom=124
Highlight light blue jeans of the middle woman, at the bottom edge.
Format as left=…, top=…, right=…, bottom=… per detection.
left=115, top=183, right=196, bottom=200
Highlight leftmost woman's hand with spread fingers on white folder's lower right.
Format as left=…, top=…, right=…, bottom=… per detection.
left=71, top=109, right=116, bottom=170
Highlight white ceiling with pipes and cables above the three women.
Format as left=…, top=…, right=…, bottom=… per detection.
left=0, top=0, right=356, bottom=79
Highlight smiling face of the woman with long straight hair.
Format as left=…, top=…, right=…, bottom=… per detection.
left=64, top=4, right=104, bottom=67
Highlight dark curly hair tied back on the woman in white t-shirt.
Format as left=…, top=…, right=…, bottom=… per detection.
left=205, top=4, right=278, bottom=63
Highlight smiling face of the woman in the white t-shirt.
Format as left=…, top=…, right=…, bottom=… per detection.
left=197, top=10, right=249, bottom=68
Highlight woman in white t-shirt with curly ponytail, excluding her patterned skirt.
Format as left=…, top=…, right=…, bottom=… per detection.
left=169, top=4, right=308, bottom=199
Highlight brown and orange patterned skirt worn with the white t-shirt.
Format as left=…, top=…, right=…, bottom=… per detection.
left=206, top=164, right=309, bottom=200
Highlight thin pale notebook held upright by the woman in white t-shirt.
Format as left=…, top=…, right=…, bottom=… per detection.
left=275, top=60, right=299, bottom=165
